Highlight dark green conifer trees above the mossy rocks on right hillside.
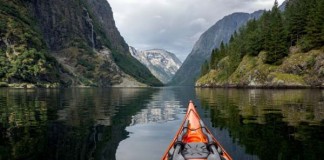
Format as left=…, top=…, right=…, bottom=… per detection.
left=201, top=0, right=324, bottom=80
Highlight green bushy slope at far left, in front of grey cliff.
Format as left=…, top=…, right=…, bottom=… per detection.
left=0, top=0, right=59, bottom=83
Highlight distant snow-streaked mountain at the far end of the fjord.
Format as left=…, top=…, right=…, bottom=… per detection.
left=129, top=47, right=182, bottom=84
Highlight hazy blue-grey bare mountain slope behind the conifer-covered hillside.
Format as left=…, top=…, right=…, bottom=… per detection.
left=170, top=10, right=264, bottom=85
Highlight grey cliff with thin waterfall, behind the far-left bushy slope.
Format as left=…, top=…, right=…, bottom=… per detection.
left=1, top=0, right=161, bottom=86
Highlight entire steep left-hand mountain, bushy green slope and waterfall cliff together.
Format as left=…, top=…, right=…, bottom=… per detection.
left=0, top=0, right=162, bottom=87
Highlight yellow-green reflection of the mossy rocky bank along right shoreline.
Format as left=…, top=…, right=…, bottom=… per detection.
left=196, top=89, right=324, bottom=125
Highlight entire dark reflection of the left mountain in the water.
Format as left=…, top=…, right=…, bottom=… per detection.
left=0, top=88, right=155, bottom=159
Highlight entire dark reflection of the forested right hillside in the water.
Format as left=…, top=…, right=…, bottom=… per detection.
left=196, top=89, right=324, bottom=160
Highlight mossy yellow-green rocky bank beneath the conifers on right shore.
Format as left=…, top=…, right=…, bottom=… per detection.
left=196, top=47, right=324, bottom=88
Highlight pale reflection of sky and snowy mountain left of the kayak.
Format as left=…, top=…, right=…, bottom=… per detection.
left=116, top=88, right=185, bottom=160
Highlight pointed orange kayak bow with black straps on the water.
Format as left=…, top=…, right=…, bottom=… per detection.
left=162, top=101, right=232, bottom=160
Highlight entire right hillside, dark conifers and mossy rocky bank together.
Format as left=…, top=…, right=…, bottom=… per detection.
left=196, top=0, right=324, bottom=87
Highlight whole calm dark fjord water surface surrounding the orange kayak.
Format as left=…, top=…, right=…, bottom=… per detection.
left=0, top=87, right=324, bottom=160
